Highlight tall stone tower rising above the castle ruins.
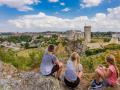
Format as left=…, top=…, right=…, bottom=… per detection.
left=84, top=26, right=91, bottom=43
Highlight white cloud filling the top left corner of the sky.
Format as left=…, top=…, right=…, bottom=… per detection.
left=0, top=0, right=40, bottom=11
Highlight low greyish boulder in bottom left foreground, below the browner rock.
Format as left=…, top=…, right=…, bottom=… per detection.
left=0, top=72, right=61, bottom=90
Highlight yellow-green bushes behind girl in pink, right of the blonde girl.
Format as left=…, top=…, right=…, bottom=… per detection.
left=81, top=50, right=120, bottom=73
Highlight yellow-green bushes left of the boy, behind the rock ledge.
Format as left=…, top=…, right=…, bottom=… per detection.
left=0, top=48, right=44, bottom=70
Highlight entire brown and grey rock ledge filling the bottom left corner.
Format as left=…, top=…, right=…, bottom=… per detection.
left=0, top=61, right=81, bottom=90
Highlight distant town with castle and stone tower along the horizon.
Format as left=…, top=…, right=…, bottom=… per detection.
left=0, top=26, right=120, bottom=50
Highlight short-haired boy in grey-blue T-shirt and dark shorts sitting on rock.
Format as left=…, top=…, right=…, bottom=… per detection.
left=40, top=45, right=63, bottom=79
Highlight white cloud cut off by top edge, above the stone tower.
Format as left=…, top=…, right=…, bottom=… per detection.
left=80, top=0, right=103, bottom=8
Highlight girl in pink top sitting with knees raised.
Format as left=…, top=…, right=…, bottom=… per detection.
left=91, top=55, right=119, bottom=89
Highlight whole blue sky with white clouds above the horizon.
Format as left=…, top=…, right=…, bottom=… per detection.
left=0, top=0, right=120, bottom=32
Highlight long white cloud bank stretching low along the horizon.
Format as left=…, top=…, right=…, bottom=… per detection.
left=8, top=6, right=120, bottom=31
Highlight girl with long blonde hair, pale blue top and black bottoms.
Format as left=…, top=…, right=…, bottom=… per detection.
left=64, top=52, right=83, bottom=88
